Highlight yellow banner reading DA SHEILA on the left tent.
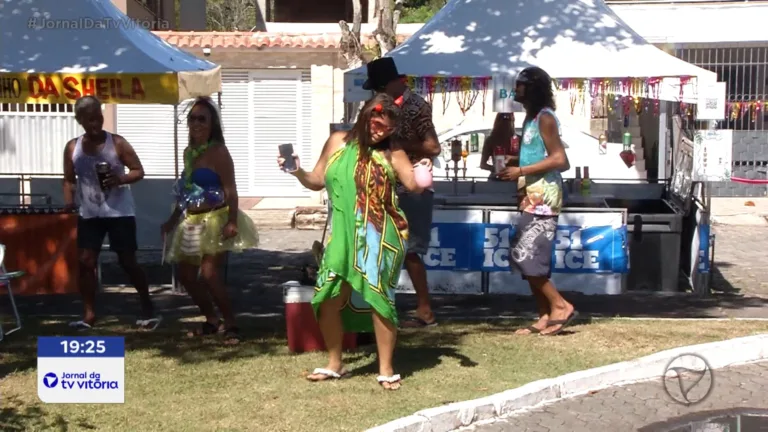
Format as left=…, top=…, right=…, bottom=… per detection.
left=0, top=72, right=179, bottom=104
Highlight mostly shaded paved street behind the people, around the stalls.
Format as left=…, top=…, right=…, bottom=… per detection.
left=9, top=226, right=768, bottom=319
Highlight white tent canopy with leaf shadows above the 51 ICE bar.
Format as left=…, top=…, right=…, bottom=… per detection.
left=344, top=0, right=715, bottom=84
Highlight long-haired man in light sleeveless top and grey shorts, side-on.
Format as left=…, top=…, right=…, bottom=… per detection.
left=499, top=67, right=577, bottom=335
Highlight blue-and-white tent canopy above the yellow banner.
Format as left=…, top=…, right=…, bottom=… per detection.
left=0, top=0, right=221, bottom=100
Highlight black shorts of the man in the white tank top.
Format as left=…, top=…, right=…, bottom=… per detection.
left=77, top=216, right=138, bottom=253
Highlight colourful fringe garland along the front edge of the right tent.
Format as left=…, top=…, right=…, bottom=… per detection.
left=405, top=75, right=700, bottom=115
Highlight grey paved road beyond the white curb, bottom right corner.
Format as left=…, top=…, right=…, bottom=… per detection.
left=466, top=362, right=768, bottom=432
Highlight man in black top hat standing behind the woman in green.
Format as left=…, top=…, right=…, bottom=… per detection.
left=363, top=57, right=440, bottom=327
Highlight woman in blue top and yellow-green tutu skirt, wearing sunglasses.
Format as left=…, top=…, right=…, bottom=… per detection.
left=162, top=97, right=259, bottom=342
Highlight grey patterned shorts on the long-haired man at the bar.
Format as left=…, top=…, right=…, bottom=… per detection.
left=509, top=212, right=557, bottom=278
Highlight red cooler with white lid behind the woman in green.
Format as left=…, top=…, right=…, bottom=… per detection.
left=283, top=281, right=357, bottom=353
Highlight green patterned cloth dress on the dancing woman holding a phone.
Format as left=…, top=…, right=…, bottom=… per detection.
left=312, top=142, right=408, bottom=332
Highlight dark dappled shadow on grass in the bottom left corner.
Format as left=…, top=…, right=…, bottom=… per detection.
left=0, top=396, right=96, bottom=432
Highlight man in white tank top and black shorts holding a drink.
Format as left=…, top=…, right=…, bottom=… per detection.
left=64, top=96, right=160, bottom=329
